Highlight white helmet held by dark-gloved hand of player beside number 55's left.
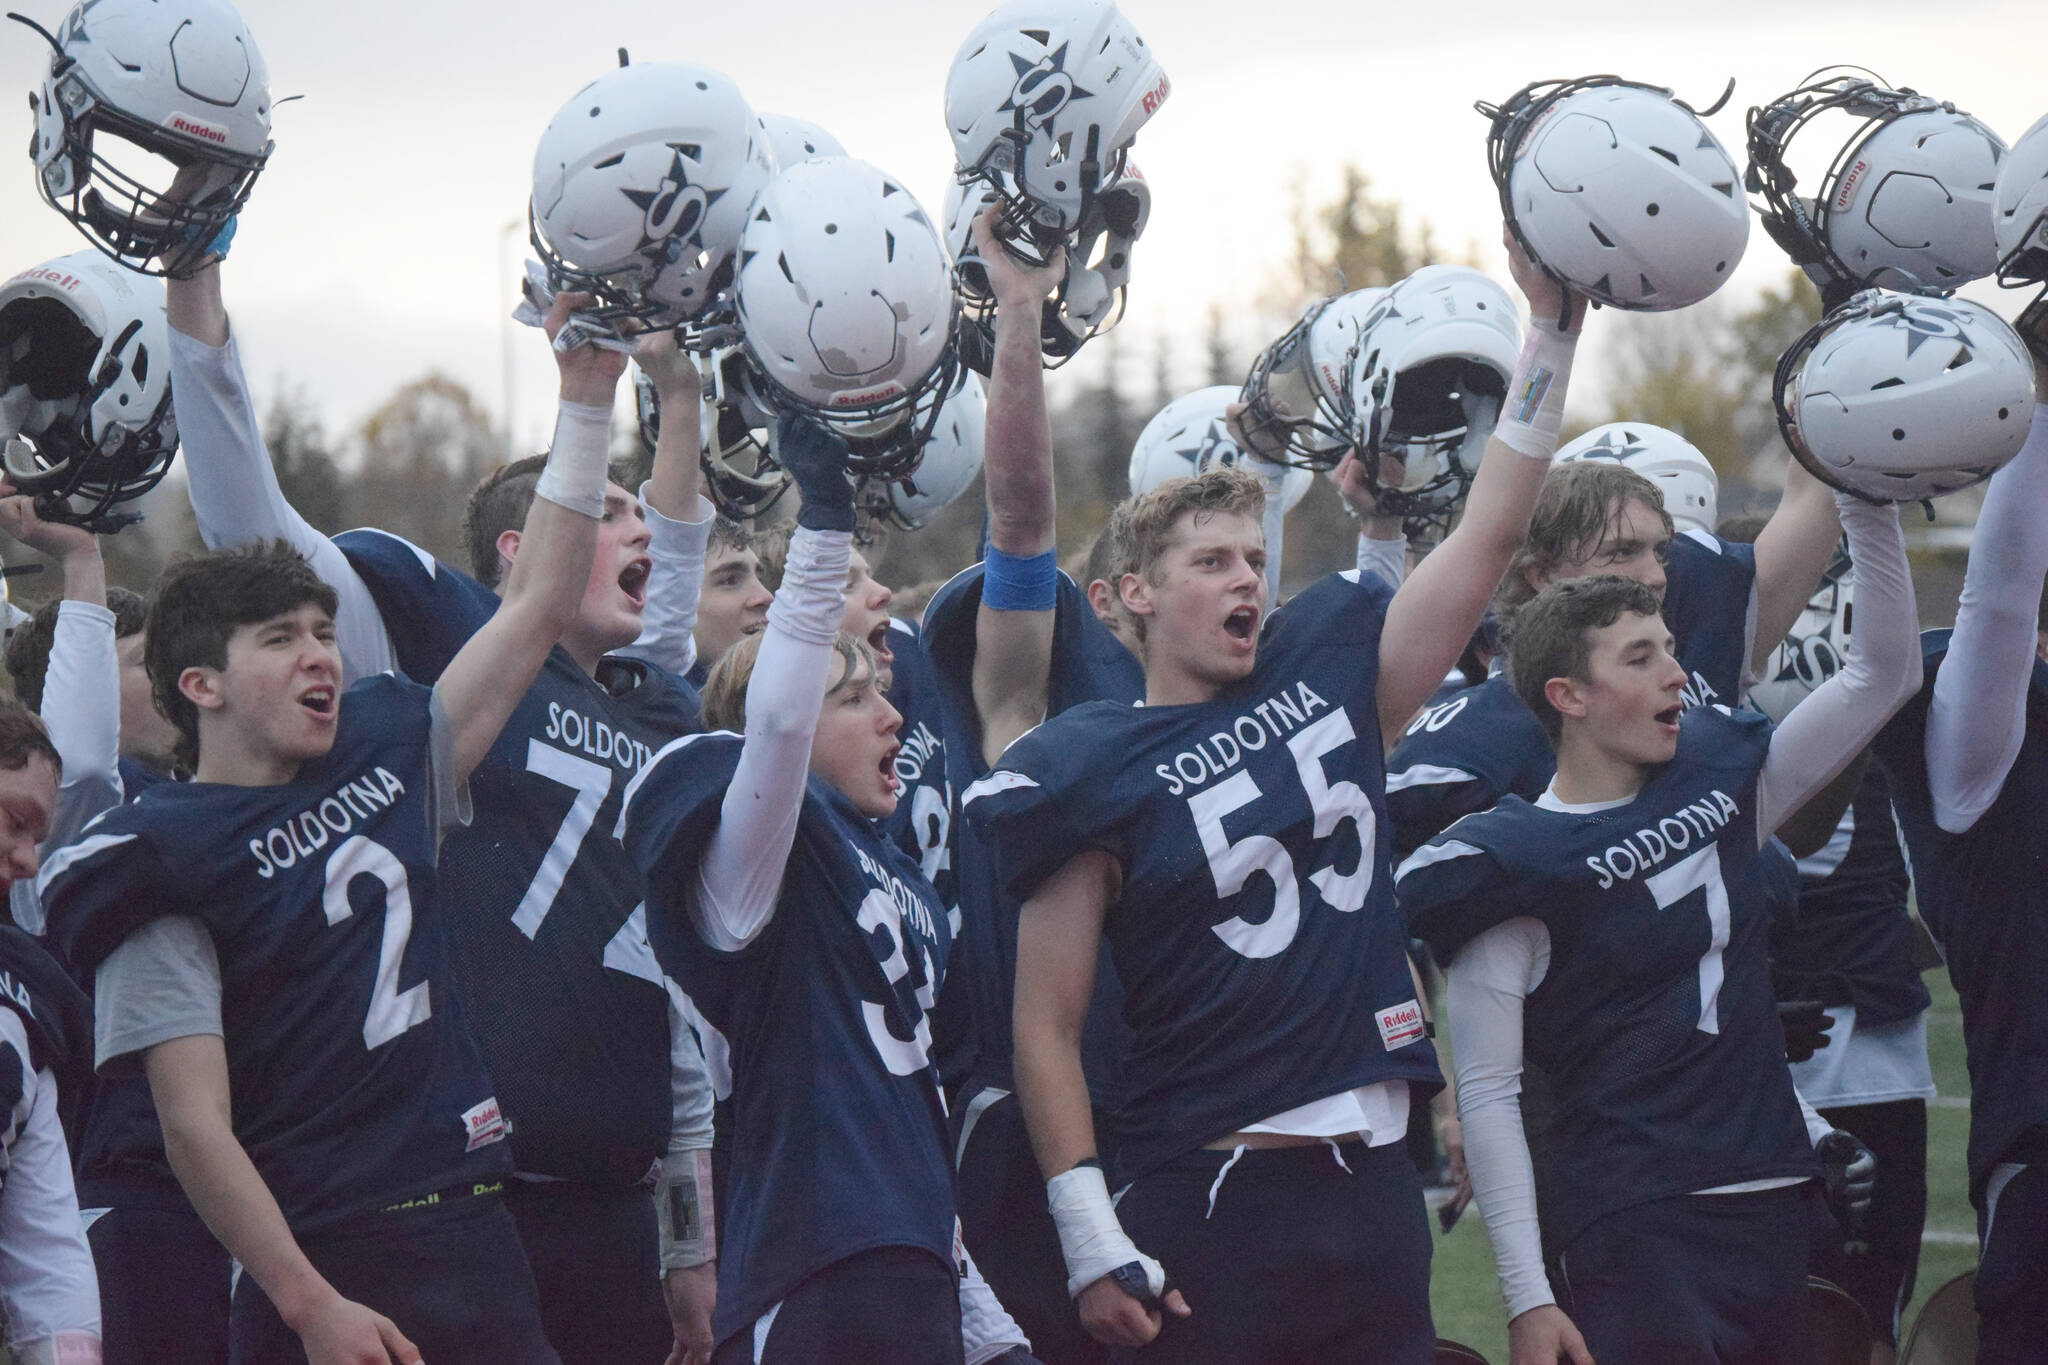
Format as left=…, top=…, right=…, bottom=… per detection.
left=735, top=158, right=958, bottom=481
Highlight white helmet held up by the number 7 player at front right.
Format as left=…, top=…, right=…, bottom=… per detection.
left=1772, top=289, right=2034, bottom=503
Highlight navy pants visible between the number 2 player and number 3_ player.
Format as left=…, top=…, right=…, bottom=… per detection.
left=503, top=1181, right=676, bottom=1365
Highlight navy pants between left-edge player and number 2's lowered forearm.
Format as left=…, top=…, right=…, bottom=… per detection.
left=86, top=1203, right=229, bottom=1365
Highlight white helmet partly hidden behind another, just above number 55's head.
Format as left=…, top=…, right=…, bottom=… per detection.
left=1239, top=289, right=1386, bottom=471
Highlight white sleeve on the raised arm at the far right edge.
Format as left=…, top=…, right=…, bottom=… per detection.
left=1916, top=405, right=2048, bottom=835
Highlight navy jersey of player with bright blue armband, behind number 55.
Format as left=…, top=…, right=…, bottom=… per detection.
left=924, top=565, right=1145, bottom=1113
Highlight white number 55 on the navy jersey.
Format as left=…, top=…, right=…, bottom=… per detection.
left=1188, top=708, right=1374, bottom=958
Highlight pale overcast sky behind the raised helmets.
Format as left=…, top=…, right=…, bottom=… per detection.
left=0, top=0, right=2048, bottom=456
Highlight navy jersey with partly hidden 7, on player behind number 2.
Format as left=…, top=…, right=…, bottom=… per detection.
left=336, top=530, right=698, bottom=1185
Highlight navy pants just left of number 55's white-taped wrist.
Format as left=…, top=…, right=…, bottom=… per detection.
left=954, top=1091, right=1110, bottom=1365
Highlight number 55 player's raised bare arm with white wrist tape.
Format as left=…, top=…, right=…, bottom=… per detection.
left=1378, top=233, right=1585, bottom=749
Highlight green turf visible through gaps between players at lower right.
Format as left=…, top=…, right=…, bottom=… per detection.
left=1430, top=970, right=1976, bottom=1365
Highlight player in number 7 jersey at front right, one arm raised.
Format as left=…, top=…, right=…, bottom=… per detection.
left=1397, top=478, right=1919, bottom=1365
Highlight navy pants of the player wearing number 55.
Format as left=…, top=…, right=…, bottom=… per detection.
left=1112, top=1142, right=1436, bottom=1365
